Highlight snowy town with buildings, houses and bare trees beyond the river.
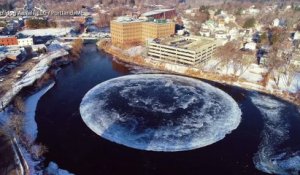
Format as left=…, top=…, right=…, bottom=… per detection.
left=0, top=0, right=300, bottom=174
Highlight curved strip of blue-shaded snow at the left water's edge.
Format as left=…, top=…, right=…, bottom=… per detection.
left=24, top=82, right=55, bottom=142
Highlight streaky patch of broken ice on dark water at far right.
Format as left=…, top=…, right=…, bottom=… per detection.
left=251, top=94, right=300, bottom=175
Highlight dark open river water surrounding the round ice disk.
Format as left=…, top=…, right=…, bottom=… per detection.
left=36, top=44, right=300, bottom=175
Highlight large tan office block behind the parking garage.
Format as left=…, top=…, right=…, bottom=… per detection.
left=110, top=17, right=175, bottom=45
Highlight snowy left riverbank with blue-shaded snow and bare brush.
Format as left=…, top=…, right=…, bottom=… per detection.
left=0, top=49, right=69, bottom=175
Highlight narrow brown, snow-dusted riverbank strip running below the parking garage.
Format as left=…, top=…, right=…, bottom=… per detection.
left=97, top=41, right=300, bottom=106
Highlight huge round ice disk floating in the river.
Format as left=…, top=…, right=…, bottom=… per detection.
left=80, top=74, right=241, bottom=152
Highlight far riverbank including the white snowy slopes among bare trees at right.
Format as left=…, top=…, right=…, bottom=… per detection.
left=98, top=42, right=300, bottom=105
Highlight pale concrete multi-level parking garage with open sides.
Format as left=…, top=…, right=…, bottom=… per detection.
left=148, top=36, right=217, bottom=66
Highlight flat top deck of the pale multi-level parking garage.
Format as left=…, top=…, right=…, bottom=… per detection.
left=155, top=36, right=214, bottom=51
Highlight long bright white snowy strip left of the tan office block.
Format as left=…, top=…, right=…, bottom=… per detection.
left=19, top=28, right=72, bottom=36
